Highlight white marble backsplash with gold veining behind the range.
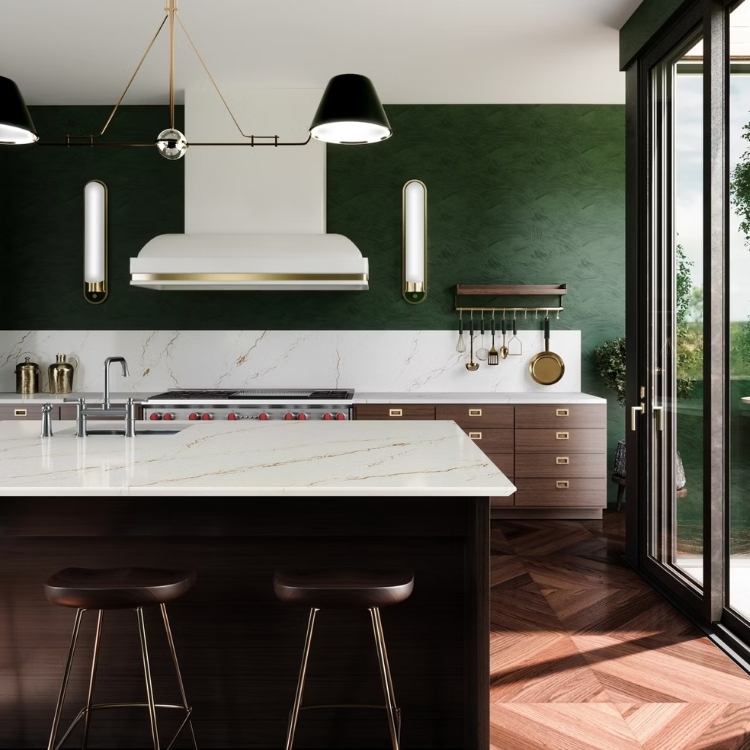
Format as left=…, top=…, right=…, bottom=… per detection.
left=0, top=330, right=581, bottom=392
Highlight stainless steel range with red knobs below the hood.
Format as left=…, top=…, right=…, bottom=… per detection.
left=143, top=388, right=354, bottom=421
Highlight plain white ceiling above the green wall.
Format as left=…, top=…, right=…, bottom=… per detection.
left=0, top=0, right=641, bottom=104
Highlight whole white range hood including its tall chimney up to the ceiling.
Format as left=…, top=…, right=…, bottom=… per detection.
left=130, top=88, right=368, bottom=291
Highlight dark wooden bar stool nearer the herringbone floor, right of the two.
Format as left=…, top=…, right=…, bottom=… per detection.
left=273, top=570, right=414, bottom=750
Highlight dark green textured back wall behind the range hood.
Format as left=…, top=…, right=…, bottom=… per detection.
left=0, top=105, right=625, bottom=506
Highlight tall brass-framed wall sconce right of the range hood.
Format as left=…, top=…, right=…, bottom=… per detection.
left=403, top=180, right=427, bottom=305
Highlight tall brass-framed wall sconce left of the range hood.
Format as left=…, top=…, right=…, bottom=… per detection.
left=83, top=180, right=108, bottom=305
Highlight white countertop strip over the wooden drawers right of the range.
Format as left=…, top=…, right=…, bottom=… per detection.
left=354, top=391, right=607, bottom=404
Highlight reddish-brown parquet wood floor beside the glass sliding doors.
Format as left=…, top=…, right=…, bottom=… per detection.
left=490, top=511, right=750, bottom=750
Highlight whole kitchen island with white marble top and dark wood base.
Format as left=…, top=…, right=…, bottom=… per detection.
left=0, top=422, right=515, bottom=750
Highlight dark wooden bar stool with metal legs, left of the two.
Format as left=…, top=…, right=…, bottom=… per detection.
left=44, top=568, right=198, bottom=750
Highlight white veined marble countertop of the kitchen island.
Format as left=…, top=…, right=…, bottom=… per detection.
left=0, top=420, right=515, bottom=497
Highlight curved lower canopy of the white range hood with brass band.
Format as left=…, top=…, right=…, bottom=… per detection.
left=130, top=234, right=368, bottom=291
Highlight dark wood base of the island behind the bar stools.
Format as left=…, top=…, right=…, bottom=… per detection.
left=0, top=497, right=489, bottom=750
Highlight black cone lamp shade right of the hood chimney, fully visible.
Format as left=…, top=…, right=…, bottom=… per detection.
left=310, top=73, right=393, bottom=146
